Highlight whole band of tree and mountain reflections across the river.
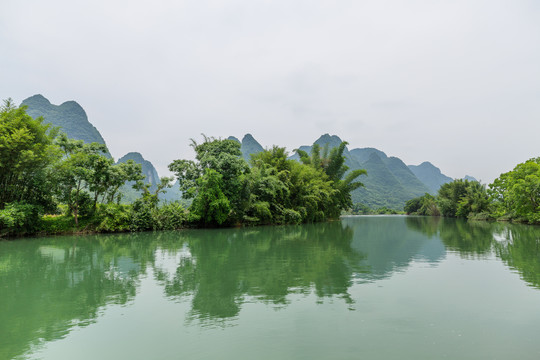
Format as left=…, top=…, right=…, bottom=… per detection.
left=0, top=217, right=540, bottom=359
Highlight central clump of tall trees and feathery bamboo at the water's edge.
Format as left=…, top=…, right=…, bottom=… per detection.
left=169, top=137, right=365, bottom=226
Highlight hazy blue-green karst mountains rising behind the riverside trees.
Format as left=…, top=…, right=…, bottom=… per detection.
left=21, top=95, right=475, bottom=209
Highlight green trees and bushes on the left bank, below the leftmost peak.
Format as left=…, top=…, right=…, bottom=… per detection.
left=0, top=100, right=187, bottom=236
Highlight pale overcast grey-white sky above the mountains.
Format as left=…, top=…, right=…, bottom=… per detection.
left=0, top=0, right=540, bottom=183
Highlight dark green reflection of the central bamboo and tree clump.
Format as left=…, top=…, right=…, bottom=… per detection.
left=159, top=222, right=363, bottom=319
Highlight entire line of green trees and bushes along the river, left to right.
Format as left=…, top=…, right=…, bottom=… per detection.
left=0, top=100, right=540, bottom=238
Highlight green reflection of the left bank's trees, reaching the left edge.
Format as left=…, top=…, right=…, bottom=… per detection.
left=0, top=236, right=153, bottom=359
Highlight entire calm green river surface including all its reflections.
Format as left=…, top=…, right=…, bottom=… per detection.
left=0, top=217, right=540, bottom=360
